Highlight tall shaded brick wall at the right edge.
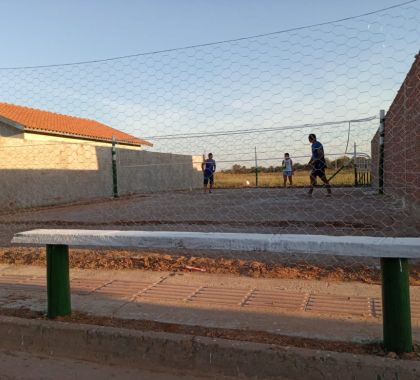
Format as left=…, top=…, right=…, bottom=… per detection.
left=372, top=54, right=420, bottom=213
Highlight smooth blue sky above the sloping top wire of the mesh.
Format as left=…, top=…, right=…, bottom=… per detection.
left=0, top=0, right=408, bottom=67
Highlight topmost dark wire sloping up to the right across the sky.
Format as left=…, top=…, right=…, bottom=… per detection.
left=0, top=0, right=418, bottom=70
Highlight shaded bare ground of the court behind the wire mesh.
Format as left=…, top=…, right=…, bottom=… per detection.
left=0, top=188, right=420, bottom=246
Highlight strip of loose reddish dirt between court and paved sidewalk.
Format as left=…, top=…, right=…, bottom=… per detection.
left=0, top=247, right=420, bottom=285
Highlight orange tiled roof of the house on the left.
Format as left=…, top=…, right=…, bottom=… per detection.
left=0, top=103, right=153, bottom=146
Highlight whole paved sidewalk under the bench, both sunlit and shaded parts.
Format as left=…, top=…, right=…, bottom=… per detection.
left=0, top=265, right=420, bottom=341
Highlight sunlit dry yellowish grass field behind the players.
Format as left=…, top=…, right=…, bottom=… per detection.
left=215, top=169, right=354, bottom=189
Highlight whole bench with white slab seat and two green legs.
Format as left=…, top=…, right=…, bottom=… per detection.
left=12, top=229, right=420, bottom=352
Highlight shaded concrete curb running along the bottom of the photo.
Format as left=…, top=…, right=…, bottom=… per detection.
left=0, top=317, right=420, bottom=380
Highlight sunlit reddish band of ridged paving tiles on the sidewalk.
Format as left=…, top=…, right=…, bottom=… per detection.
left=0, top=275, right=420, bottom=321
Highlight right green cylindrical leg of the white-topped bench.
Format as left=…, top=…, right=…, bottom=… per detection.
left=381, top=258, right=413, bottom=352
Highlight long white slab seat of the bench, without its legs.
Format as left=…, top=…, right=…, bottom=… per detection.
left=12, top=229, right=420, bottom=258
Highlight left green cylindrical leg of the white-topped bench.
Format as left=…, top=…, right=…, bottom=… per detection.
left=47, top=245, right=71, bottom=318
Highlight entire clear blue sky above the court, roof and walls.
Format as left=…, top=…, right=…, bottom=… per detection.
left=0, top=0, right=420, bottom=167
